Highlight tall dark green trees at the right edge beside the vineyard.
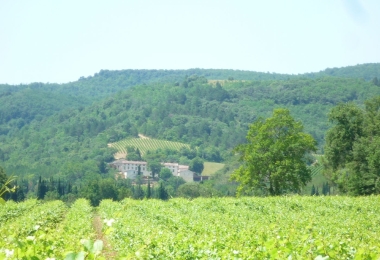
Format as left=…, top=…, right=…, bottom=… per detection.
left=324, top=96, right=380, bottom=195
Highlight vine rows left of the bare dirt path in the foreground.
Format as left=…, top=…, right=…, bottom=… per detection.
left=0, top=199, right=101, bottom=259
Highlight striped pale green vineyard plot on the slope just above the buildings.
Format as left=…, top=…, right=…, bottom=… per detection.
left=110, top=138, right=190, bottom=155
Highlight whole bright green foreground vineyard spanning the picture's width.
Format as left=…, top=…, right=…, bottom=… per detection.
left=0, top=196, right=380, bottom=259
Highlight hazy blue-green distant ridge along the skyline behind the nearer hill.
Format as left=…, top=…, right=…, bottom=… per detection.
left=0, top=63, right=380, bottom=137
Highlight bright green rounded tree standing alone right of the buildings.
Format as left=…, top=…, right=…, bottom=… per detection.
left=231, top=109, right=316, bottom=196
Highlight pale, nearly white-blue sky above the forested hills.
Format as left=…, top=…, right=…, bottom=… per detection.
left=0, top=0, right=380, bottom=84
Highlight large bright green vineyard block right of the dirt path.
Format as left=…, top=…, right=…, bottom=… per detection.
left=99, top=197, right=380, bottom=259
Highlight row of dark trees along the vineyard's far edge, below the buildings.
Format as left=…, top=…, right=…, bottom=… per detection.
left=0, top=165, right=229, bottom=206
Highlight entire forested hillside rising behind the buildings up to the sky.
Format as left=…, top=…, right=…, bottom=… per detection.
left=0, top=64, right=380, bottom=197
